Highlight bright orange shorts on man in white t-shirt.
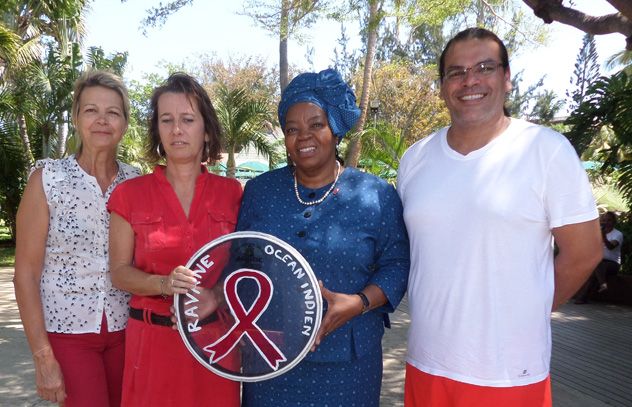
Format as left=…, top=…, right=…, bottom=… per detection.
left=404, top=363, right=552, bottom=407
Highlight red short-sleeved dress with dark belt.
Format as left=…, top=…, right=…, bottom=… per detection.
left=108, top=166, right=242, bottom=406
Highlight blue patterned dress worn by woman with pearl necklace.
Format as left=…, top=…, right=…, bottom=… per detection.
left=237, top=167, right=410, bottom=407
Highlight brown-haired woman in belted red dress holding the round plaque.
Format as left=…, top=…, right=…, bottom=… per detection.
left=108, top=73, right=242, bottom=407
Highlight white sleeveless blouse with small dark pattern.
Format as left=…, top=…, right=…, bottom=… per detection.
left=35, top=155, right=140, bottom=334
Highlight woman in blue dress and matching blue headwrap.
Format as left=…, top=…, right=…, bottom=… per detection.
left=237, top=69, right=410, bottom=407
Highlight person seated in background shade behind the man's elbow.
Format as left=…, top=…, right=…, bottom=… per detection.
left=575, top=212, right=623, bottom=304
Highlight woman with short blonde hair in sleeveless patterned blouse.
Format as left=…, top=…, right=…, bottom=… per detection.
left=13, top=71, right=140, bottom=407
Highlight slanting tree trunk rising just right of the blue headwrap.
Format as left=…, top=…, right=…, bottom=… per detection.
left=345, top=0, right=382, bottom=167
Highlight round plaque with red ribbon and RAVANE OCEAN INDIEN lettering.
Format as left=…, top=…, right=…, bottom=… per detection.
left=173, top=232, right=323, bottom=382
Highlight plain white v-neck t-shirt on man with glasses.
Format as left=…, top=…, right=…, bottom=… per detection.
left=398, top=119, right=598, bottom=387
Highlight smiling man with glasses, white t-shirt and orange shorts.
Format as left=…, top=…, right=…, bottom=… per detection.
left=398, top=28, right=601, bottom=407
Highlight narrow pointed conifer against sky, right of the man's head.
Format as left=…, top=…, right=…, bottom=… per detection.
left=566, top=34, right=599, bottom=110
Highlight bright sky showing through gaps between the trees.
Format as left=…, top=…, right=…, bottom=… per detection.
left=84, top=0, right=625, bottom=105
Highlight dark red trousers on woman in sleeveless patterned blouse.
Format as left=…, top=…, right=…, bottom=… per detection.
left=48, top=315, right=125, bottom=407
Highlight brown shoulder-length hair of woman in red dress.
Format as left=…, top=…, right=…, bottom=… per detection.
left=147, top=72, right=222, bottom=164
